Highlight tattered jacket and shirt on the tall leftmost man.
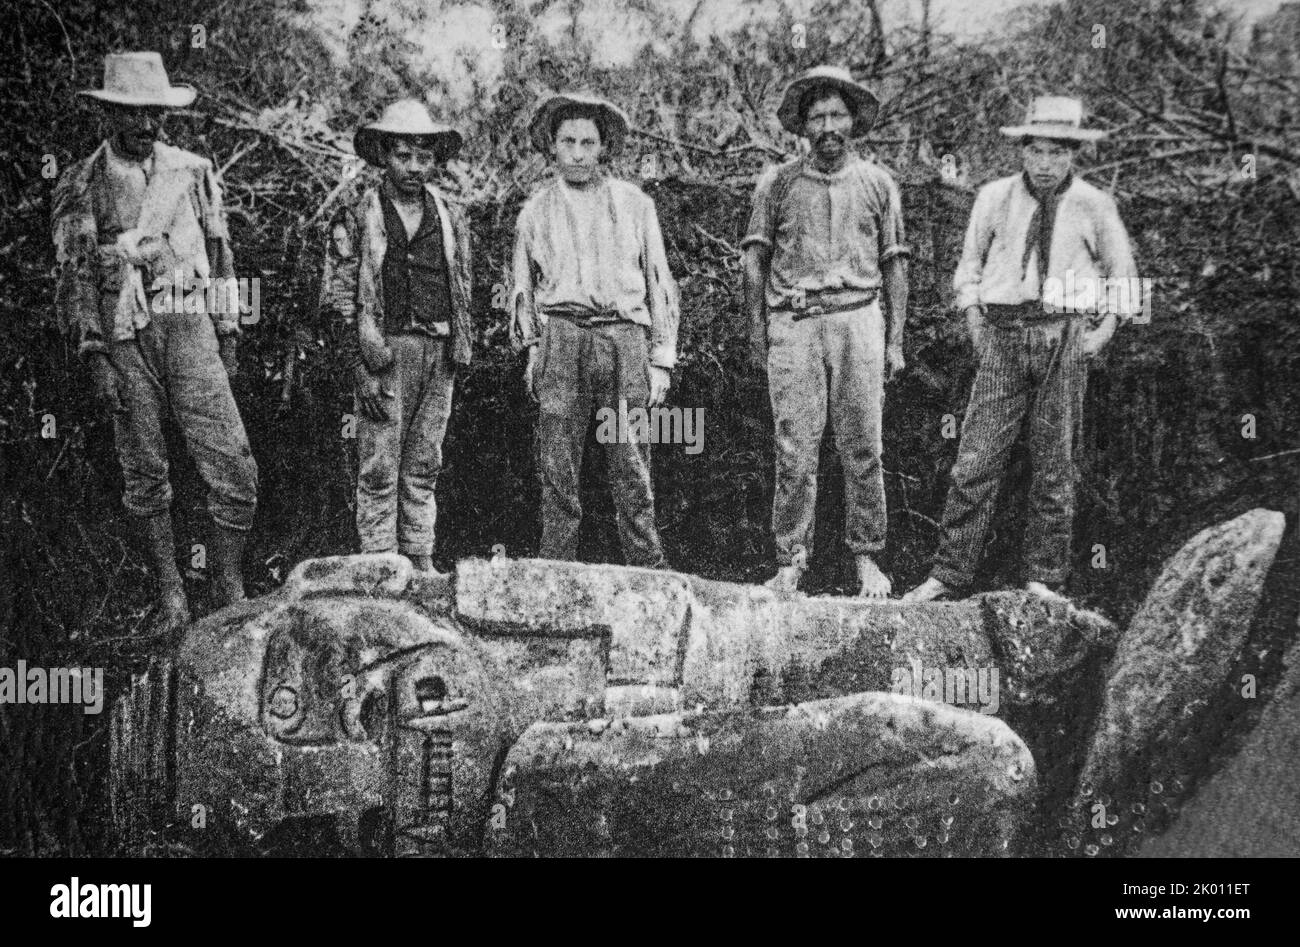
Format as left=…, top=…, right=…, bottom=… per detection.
left=51, top=142, right=239, bottom=356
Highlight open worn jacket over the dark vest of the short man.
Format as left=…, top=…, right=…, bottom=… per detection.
left=320, top=185, right=473, bottom=372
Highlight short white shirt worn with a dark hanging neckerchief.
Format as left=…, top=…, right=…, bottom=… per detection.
left=953, top=174, right=1141, bottom=316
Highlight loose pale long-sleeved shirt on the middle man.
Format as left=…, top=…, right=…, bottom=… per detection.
left=510, top=177, right=680, bottom=368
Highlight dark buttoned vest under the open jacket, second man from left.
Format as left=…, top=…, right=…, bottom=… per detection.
left=380, top=194, right=451, bottom=336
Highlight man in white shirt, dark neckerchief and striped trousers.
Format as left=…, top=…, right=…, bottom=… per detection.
left=904, top=96, right=1140, bottom=601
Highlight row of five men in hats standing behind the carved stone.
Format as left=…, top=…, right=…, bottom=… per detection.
left=53, top=53, right=1132, bottom=634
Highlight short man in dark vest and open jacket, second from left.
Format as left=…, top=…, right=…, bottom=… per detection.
left=321, top=99, right=472, bottom=571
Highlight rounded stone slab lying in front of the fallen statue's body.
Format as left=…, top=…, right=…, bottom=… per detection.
left=488, top=693, right=1035, bottom=857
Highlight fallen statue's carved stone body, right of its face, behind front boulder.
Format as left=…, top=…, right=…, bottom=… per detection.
left=455, top=559, right=1117, bottom=714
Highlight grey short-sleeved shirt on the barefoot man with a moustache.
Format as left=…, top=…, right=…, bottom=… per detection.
left=741, top=157, right=911, bottom=310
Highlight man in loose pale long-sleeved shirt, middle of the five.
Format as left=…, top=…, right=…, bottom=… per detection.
left=511, top=94, right=679, bottom=567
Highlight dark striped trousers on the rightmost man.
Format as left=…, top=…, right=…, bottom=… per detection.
left=931, top=319, right=1088, bottom=589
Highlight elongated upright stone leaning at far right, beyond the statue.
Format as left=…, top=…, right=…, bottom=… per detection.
left=1073, top=510, right=1284, bottom=851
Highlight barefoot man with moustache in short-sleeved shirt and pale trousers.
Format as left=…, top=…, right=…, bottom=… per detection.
left=741, top=66, right=910, bottom=598
